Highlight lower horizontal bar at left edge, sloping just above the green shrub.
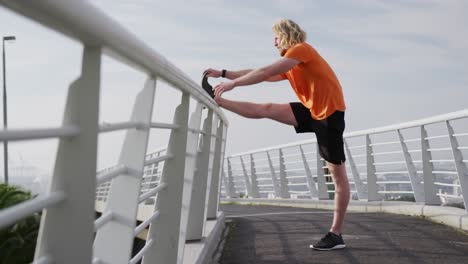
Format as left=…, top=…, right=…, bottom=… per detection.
left=0, top=191, right=66, bottom=229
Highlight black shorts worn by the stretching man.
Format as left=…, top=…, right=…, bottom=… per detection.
left=289, top=102, right=346, bottom=164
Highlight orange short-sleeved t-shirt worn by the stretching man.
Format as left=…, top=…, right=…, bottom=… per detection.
left=282, top=42, right=346, bottom=120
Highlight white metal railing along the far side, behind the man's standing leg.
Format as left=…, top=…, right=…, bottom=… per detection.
left=222, top=110, right=468, bottom=211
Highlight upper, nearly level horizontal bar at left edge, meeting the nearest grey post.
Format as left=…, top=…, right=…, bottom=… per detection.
left=0, top=125, right=80, bottom=141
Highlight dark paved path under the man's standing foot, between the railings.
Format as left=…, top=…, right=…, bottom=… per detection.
left=219, top=205, right=468, bottom=264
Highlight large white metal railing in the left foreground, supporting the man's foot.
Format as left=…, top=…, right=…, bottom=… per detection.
left=0, top=0, right=228, bottom=264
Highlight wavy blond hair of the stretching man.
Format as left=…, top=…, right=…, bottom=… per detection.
left=273, top=19, right=307, bottom=49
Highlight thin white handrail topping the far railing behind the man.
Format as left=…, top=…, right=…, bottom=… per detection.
left=226, top=109, right=468, bottom=158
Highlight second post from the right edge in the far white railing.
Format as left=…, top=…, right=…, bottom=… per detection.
left=421, top=126, right=440, bottom=205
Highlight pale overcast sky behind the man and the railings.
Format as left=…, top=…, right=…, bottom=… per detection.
left=0, top=0, right=468, bottom=179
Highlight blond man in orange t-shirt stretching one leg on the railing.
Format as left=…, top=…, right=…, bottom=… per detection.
left=204, top=19, right=350, bottom=250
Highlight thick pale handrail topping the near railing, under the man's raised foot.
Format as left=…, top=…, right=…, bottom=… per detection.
left=1, top=0, right=229, bottom=125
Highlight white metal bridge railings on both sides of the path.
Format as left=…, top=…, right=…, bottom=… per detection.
left=0, top=0, right=468, bottom=264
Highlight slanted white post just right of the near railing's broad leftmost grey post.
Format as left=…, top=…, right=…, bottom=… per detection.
left=94, top=76, right=156, bottom=263
